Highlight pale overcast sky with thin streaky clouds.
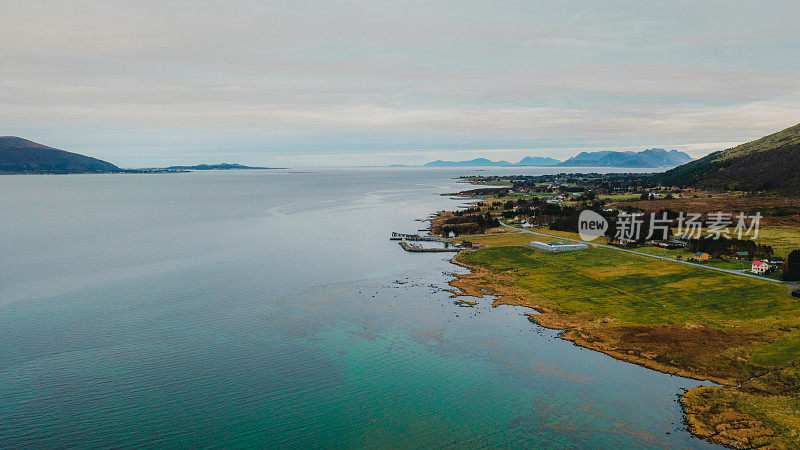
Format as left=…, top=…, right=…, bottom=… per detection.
left=0, top=0, right=800, bottom=167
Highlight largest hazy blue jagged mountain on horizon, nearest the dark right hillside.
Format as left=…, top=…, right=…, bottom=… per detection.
left=559, top=148, right=692, bottom=168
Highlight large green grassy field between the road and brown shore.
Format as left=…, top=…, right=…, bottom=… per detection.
left=465, top=244, right=800, bottom=325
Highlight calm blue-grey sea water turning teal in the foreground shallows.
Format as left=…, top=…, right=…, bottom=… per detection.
left=0, top=169, right=705, bottom=448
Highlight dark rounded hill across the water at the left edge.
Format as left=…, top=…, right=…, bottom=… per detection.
left=0, top=136, right=121, bottom=174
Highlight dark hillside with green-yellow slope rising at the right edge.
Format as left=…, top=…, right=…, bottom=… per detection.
left=659, top=124, right=800, bottom=191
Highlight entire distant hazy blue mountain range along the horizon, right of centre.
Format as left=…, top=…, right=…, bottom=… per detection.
left=425, top=148, right=692, bottom=168
